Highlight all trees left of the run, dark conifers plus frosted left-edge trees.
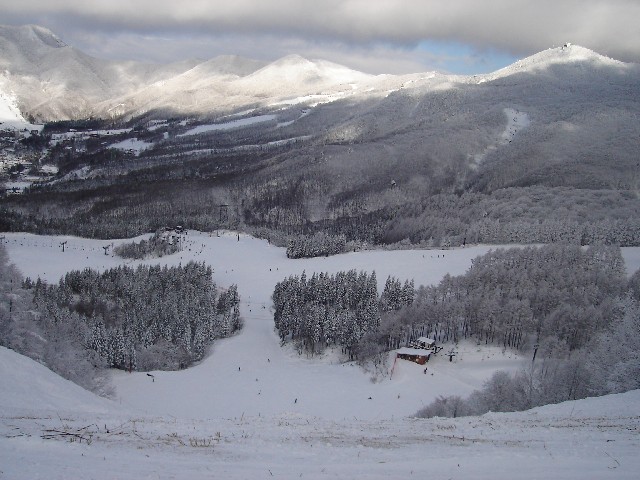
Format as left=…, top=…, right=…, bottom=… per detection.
left=0, top=249, right=242, bottom=391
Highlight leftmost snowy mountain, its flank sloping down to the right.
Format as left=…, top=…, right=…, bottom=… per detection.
left=0, top=25, right=202, bottom=120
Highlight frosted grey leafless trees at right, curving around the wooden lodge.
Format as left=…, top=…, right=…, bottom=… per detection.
left=398, top=245, right=640, bottom=417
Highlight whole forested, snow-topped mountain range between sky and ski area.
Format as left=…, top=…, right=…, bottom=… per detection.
left=0, top=27, right=640, bottom=248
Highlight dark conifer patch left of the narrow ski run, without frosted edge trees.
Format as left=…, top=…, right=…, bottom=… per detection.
left=25, top=262, right=241, bottom=370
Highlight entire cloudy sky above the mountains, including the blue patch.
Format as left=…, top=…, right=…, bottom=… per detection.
left=0, top=0, right=640, bottom=74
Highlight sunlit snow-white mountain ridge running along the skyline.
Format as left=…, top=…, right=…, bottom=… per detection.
left=0, top=25, right=634, bottom=121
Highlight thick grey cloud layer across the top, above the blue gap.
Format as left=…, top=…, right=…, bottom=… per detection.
left=0, top=0, right=640, bottom=69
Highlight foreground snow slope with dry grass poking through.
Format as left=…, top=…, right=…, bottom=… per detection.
left=0, top=340, right=640, bottom=480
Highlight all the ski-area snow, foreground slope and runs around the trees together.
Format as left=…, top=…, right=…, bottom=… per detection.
left=0, top=232, right=640, bottom=480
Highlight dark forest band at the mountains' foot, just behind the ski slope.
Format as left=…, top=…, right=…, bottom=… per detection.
left=0, top=176, right=640, bottom=258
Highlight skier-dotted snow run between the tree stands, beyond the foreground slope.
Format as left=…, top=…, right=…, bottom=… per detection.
left=6, top=232, right=520, bottom=420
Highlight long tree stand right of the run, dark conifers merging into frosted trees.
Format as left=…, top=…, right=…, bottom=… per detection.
left=273, top=245, right=640, bottom=398
